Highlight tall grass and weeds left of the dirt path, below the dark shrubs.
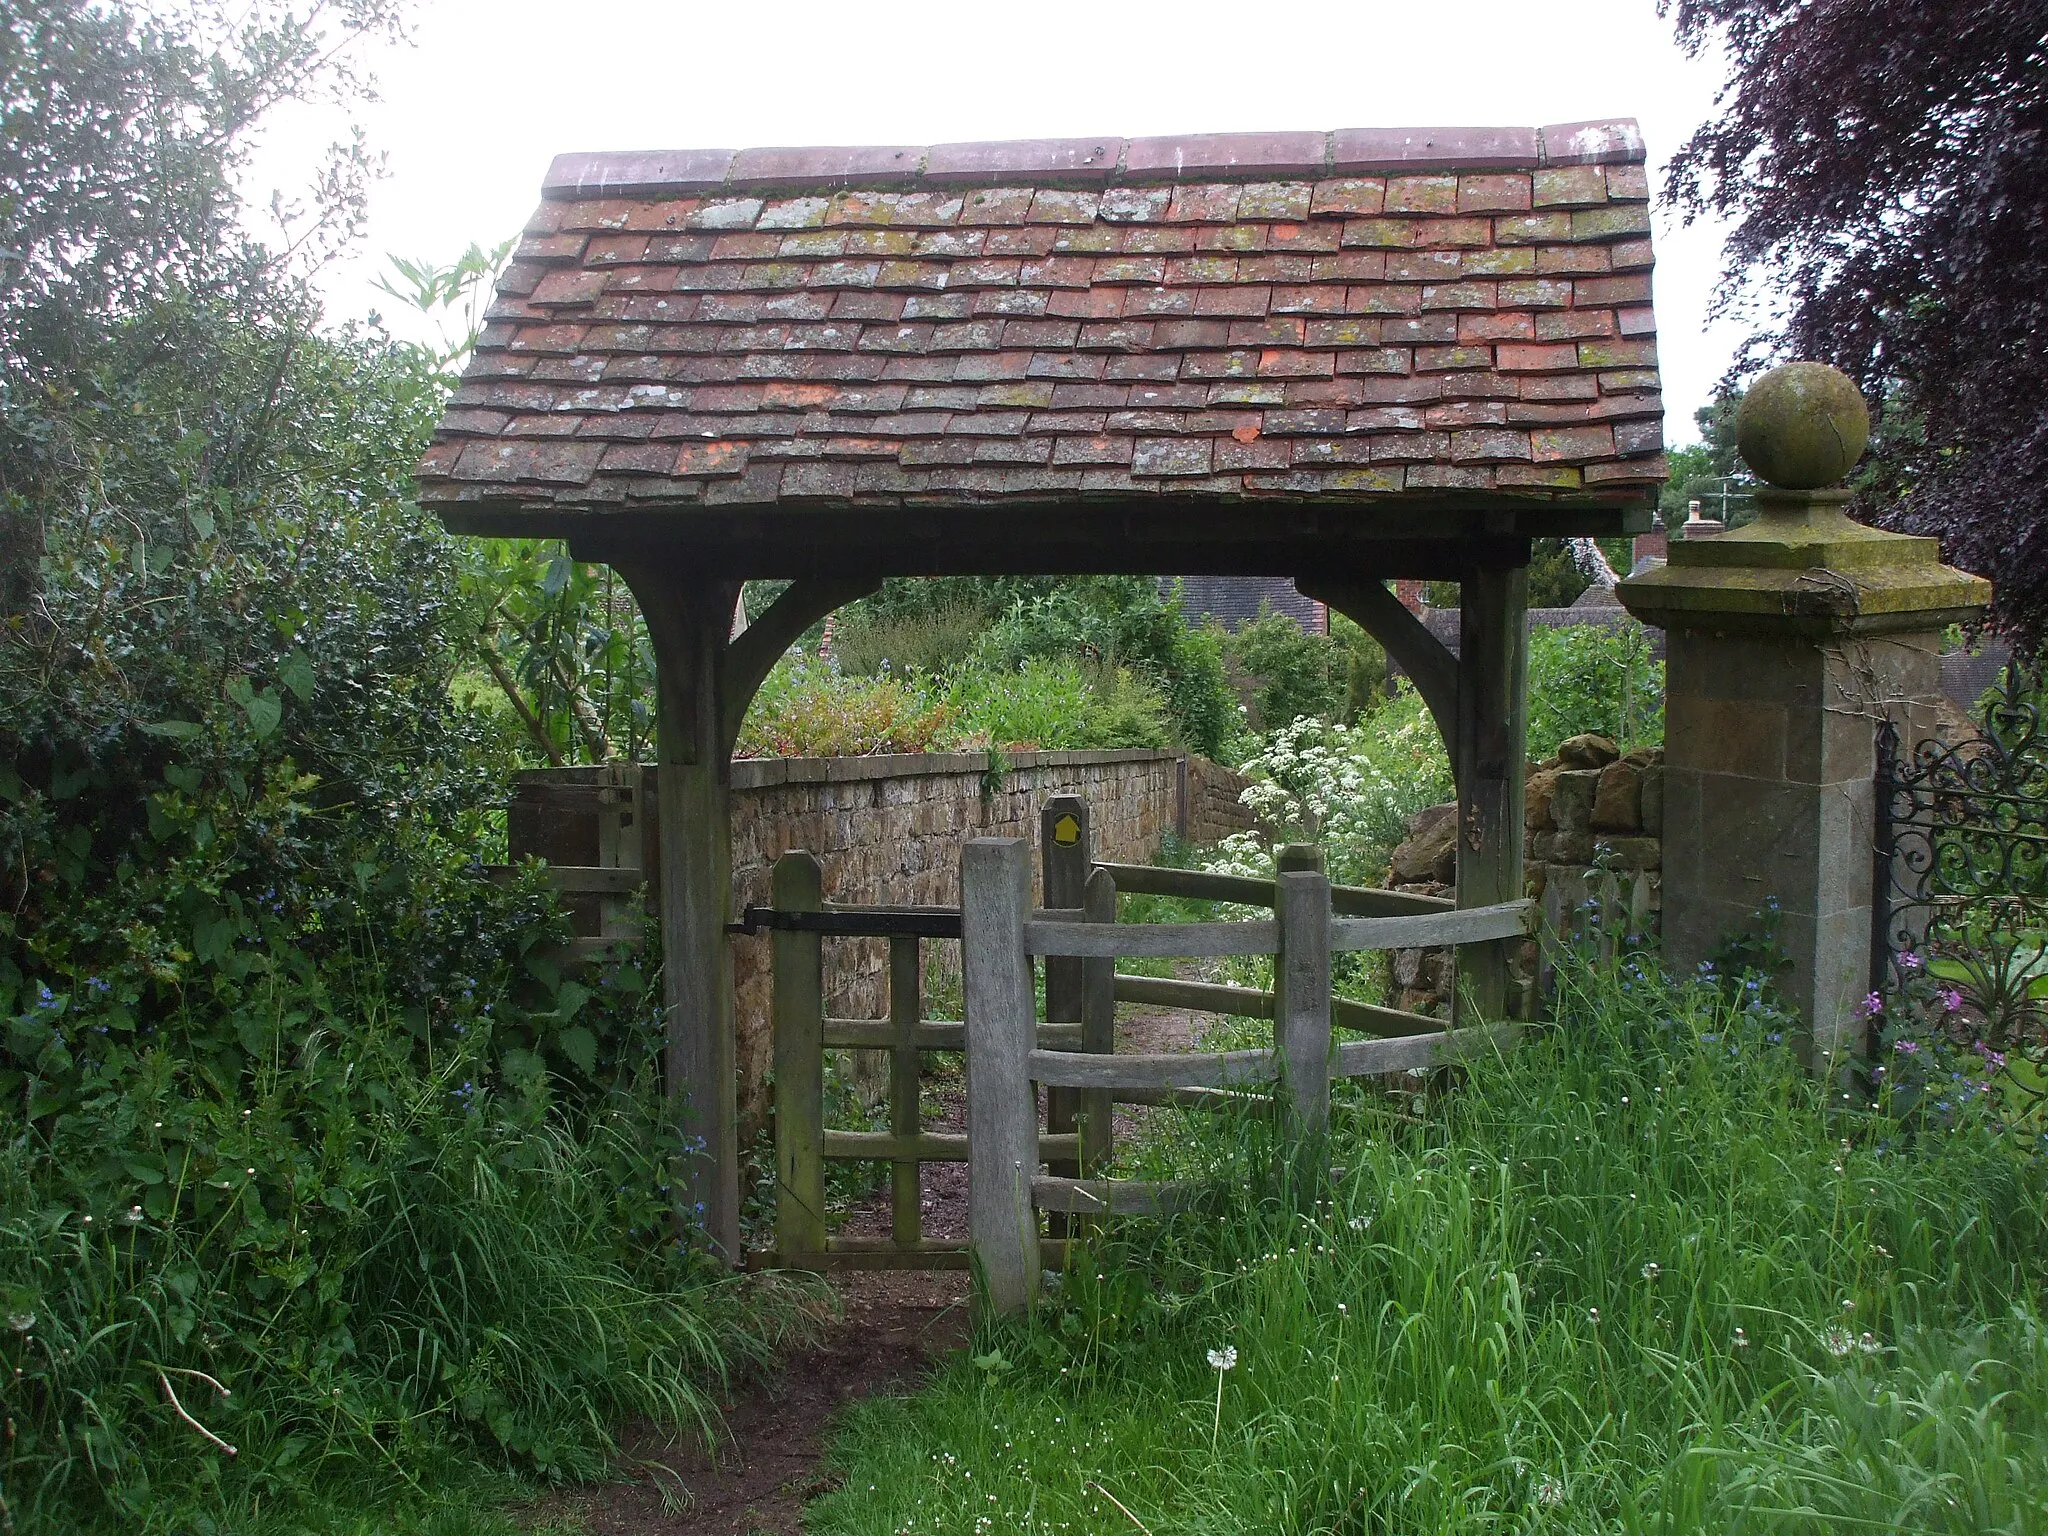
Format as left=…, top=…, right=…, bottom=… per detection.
left=0, top=1040, right=817, bottom=1532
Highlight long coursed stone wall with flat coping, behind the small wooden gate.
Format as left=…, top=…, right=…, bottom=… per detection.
left=733, top=752, right=1192, bottom=1120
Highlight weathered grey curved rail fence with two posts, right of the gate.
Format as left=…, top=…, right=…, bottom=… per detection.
left=961, top=838, right=1536, bottom=1311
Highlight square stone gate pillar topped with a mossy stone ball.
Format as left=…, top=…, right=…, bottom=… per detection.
left=1618, top=362, right=1991, bottom=1071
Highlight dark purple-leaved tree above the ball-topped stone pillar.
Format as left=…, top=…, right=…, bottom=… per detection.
left=1661, top=0, right=2048, bottom=639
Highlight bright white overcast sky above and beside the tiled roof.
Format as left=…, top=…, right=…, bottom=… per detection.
left=256, top=0, right=1741, bottom=442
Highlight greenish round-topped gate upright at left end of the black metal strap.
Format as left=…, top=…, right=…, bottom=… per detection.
left=768, top=848, right=825, bottom=1262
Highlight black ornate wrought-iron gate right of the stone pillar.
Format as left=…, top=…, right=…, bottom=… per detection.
left=1870, top=666, right=2048, bottom=1049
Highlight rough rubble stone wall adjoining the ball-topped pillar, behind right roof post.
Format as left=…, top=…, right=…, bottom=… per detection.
left=1384, top=735, right=1665, bottom=1014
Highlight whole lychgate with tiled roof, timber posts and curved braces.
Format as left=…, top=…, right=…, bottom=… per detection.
left=420, top=121, right=1665, bottom=1255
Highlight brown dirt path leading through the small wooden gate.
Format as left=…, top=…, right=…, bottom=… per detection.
left=539, top=1010, right=1200, bottom=1536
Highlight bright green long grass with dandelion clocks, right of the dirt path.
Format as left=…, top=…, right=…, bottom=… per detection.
left=811, top=967, right=2048, bottom=1536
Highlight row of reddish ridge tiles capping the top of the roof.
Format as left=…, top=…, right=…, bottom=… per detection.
left=541, top=117, right=1647, bottom=199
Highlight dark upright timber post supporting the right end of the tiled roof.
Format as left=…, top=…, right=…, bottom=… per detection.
left=1452, top=565, right=1528, bottom=1024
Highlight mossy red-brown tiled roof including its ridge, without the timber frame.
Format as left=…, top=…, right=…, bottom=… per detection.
left=420, top=121, right=1665, bottom=514
